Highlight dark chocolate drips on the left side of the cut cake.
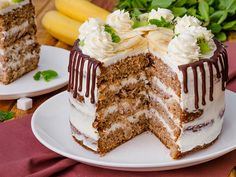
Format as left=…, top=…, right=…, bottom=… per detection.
left=68, top=40, right=102, bottom=104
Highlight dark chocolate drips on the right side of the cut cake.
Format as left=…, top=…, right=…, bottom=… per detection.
left=179, top=40, right=228, bottom=109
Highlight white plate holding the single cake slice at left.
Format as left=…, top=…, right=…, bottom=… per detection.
left=0, top=45, right=69, bottom=100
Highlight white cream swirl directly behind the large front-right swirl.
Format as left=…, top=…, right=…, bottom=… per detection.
left=175, top=15, right=201, bottom=34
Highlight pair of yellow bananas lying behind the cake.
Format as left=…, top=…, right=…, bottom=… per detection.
left=42, top=0, right=109, bottom=45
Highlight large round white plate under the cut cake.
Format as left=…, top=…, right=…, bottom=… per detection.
left=31, top=91, right=236, bottom=171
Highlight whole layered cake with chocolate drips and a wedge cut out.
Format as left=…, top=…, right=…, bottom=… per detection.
left=68, top=9, right=228, bottom=159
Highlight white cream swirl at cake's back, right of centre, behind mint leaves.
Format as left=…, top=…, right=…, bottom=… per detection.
left=148, top=8, right=174, bottom=22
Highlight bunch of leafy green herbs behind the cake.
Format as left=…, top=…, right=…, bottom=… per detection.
left=117, top=0, right=236, bottom=41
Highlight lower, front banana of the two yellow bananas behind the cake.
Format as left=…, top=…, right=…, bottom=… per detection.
left=42, top=11, right=81, bottom=45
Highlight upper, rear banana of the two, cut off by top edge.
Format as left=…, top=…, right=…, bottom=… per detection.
left=55, top=0, right=109, bottom=22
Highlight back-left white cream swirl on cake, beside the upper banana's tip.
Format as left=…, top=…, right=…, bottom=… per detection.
left=106, top=10, right=133, bottom=33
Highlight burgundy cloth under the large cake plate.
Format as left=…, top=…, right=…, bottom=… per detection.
left=0, top=43, right=236, bottom=177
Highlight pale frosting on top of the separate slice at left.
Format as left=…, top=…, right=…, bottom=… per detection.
left=0, top=0, right=30, bottom=15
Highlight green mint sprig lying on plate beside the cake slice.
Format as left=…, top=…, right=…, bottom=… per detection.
left=33, top=70, right=58, bottom=82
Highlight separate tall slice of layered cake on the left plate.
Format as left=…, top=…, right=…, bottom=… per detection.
left=0, top=0, right=40, bottom=84
